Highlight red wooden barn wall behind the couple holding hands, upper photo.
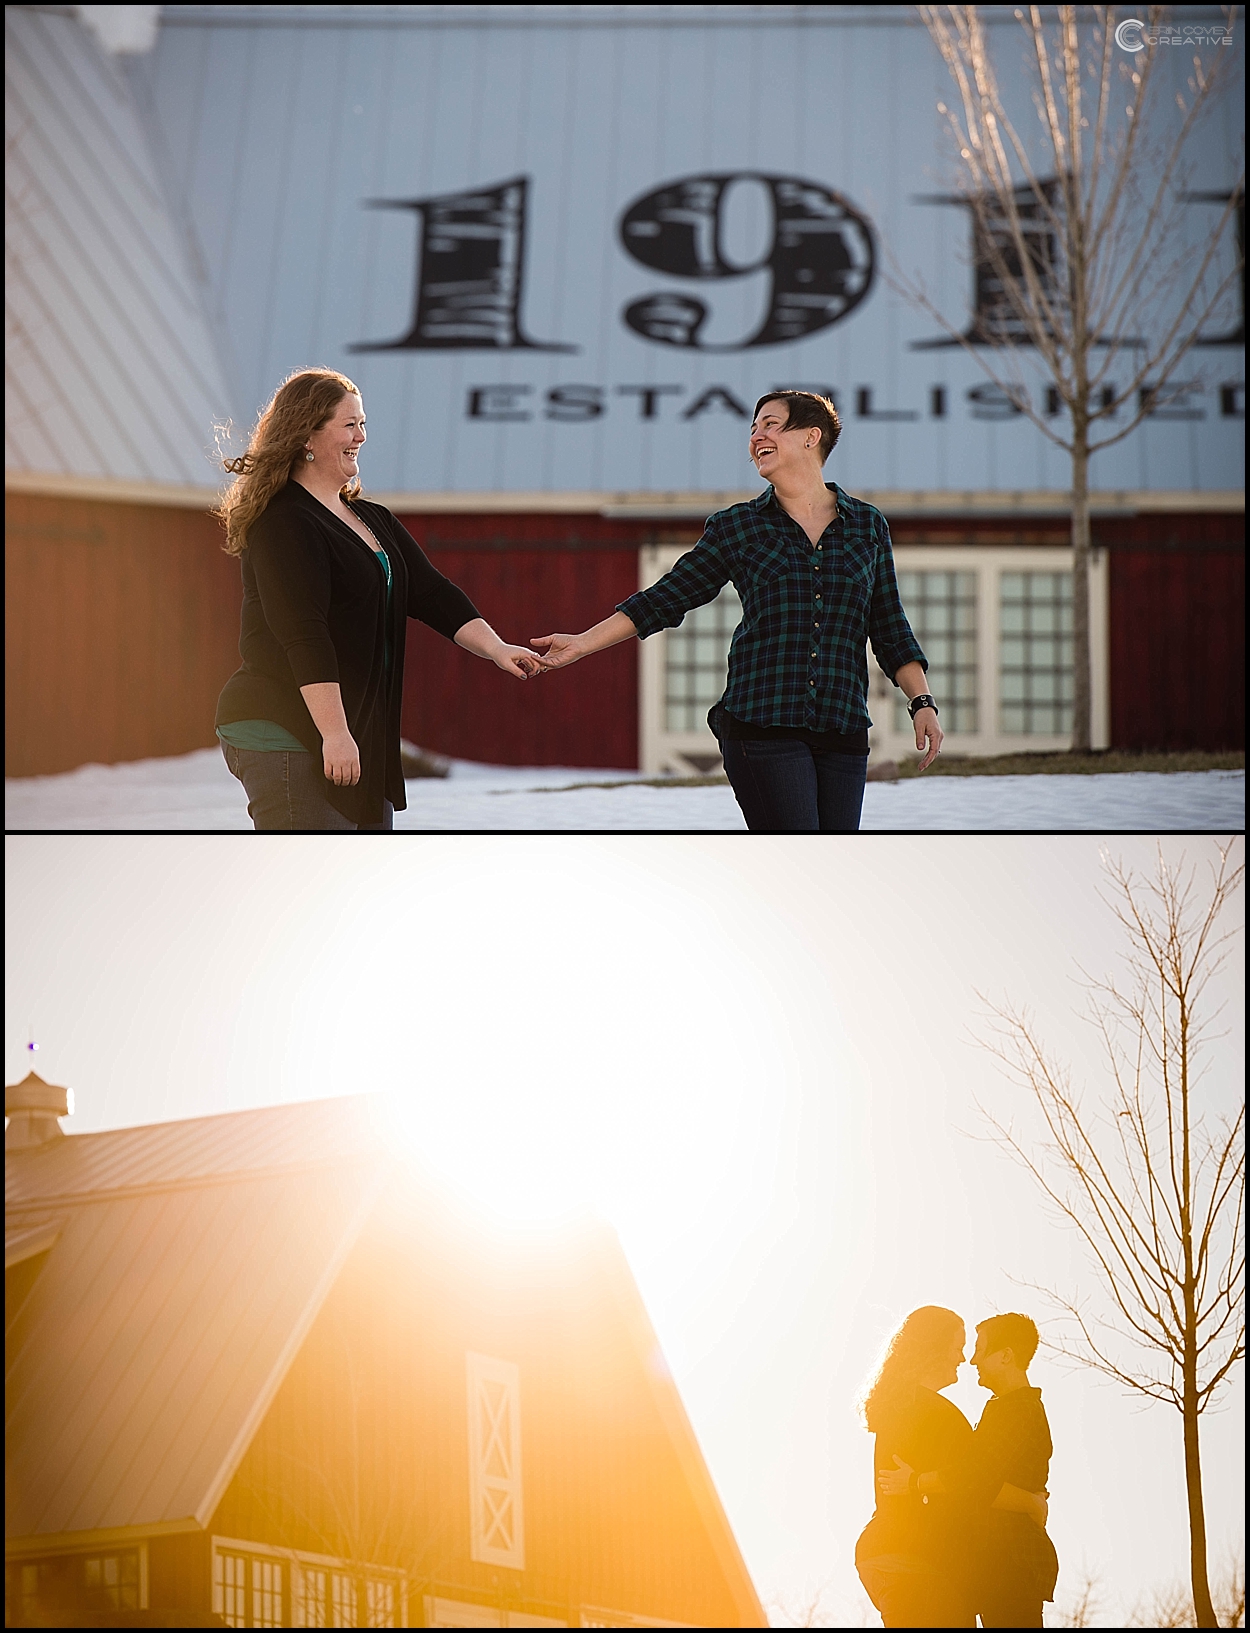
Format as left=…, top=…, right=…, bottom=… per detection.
left=5, top=493, right=1245, bottom=777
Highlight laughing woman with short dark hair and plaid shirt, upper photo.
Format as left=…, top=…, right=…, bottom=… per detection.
left=531, top=390, right=943, bottom=833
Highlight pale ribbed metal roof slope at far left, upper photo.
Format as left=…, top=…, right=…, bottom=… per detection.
left=5, top=7, right=230, bottom=488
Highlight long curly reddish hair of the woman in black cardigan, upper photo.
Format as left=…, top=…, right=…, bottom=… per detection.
left=212, top=369, right=359, bottom=555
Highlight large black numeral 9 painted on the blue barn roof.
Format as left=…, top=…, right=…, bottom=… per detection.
left=619, top=170, right=876, bottom=351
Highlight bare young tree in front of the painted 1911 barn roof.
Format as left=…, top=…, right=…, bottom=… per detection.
left=894, top=5, right=1245, bottom=753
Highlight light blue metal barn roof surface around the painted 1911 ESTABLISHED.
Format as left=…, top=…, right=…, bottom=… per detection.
left=111, top=7, right=1242, bottom=492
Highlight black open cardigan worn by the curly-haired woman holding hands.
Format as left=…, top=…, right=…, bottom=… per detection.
left=217, top=482, right=479, bottom=825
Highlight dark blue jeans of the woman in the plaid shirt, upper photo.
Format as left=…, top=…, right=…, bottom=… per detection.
left=721, top=738, right=868, bottom=833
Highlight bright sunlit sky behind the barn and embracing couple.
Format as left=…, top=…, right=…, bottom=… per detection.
left=5, top=834, right=1243, bottom=1626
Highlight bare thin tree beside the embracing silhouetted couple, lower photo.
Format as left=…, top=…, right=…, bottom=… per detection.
left=980, top=841, right=1245, bottom=1626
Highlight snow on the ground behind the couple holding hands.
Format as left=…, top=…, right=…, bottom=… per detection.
left=5, top=748, right=1245, bottom=833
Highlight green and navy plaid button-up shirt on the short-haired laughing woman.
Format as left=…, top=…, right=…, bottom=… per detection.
left=618, top=482, right=928, bottom=732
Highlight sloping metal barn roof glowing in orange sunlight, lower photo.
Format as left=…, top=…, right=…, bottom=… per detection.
left=5, top=1097, right=389, bottom=1538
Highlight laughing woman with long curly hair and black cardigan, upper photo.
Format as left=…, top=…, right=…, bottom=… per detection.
left=217, top=369, right=539, bottom=831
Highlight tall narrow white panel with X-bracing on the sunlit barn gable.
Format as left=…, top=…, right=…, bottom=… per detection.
left=466, top=1354, right=525, bottom=1571
